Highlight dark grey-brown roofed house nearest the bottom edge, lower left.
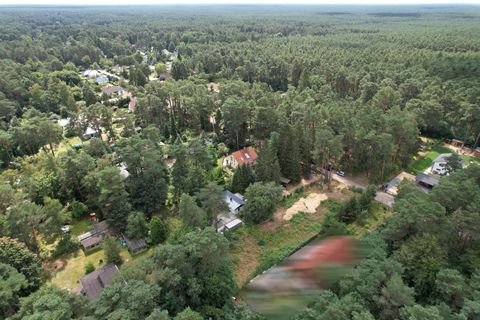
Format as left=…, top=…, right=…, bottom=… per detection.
left=80, top=263, right=119, bottom=300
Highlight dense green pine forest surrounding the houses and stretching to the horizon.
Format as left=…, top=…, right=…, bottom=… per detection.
left=0, top=6, right=480, bottom=320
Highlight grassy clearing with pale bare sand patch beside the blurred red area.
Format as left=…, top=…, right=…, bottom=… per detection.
left=229, top=182, right=352, bottom=287
